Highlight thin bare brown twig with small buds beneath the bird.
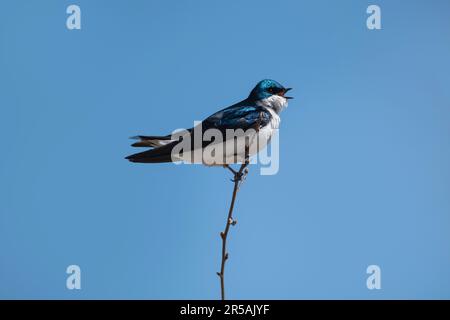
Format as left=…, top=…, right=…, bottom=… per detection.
left=217, top=148, right=249, bottom=300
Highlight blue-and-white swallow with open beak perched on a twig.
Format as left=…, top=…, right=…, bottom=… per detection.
left=125, top=79, right=293, bottom=167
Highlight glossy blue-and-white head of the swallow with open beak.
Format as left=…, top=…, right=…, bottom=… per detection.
left=248, top=79, right=292, bottom=113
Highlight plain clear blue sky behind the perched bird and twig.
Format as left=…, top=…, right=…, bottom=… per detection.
left=0, top=0, right=450, bottom=299
